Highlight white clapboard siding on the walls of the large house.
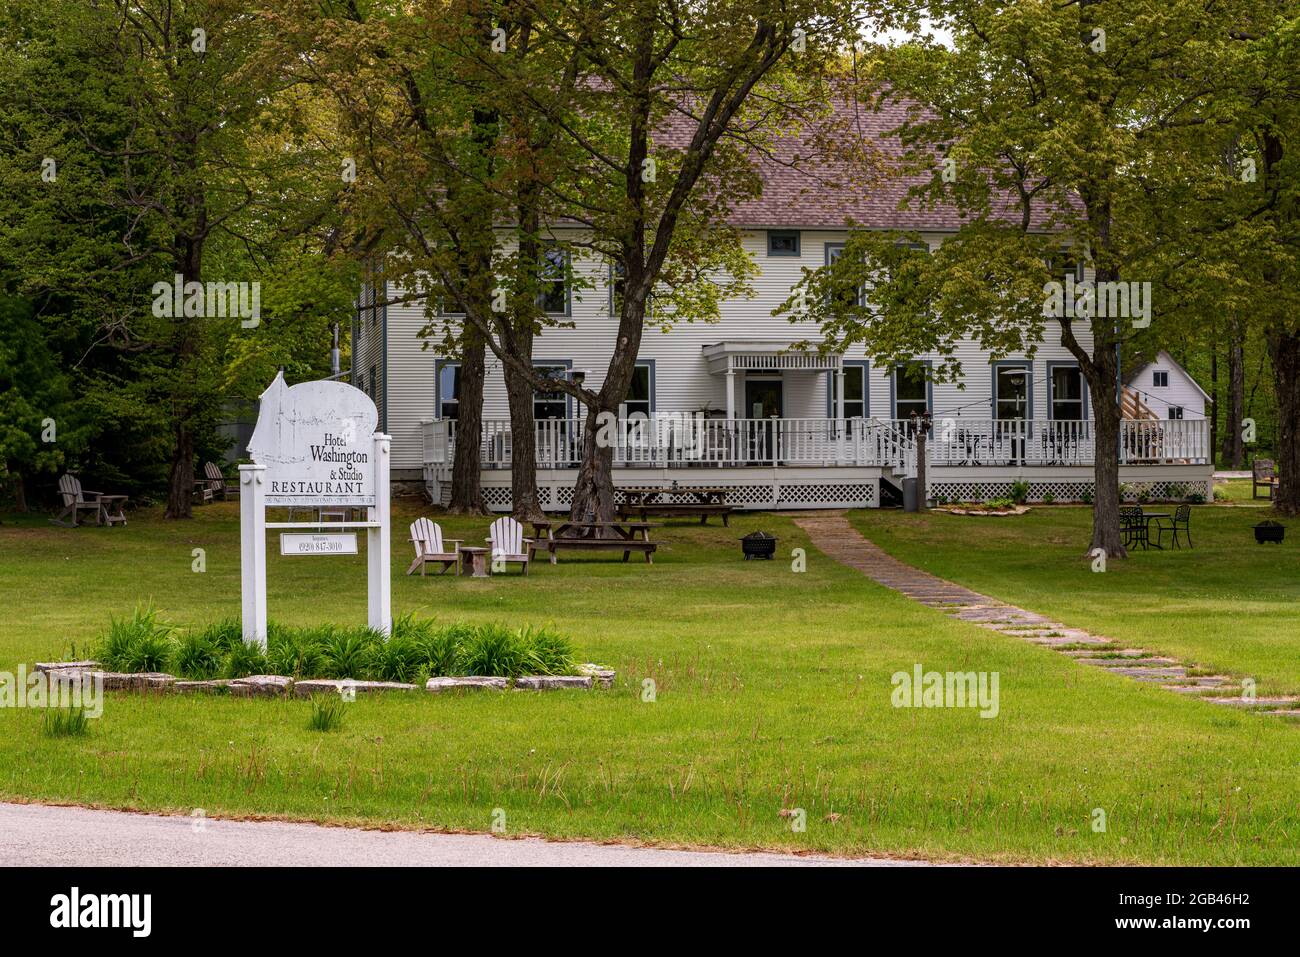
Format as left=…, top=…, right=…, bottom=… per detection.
left=374, top=230, right=1091, bottom=469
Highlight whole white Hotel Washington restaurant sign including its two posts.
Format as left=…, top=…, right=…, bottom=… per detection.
left=239, top=373, right=393, bottom=649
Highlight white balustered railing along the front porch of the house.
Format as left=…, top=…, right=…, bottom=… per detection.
left=423, top=415, right=1210, bottom=475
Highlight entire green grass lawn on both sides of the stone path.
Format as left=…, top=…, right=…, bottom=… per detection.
left=0, top=503, right=1300, bottom=865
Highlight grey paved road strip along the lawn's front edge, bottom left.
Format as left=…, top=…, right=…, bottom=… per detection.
left=0, top=804, right=915, bottom=867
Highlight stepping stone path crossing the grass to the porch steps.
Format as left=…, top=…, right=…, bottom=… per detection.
left=794, top=511, right=1300, bottom=716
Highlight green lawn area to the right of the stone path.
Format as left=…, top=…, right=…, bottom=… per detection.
left=853, top=505, right=1300, bottom=694
